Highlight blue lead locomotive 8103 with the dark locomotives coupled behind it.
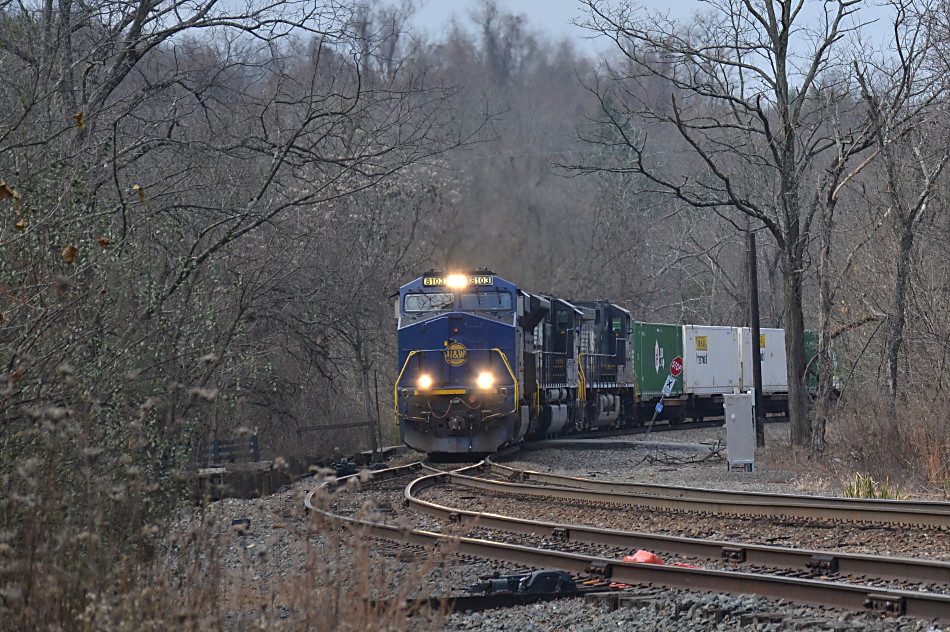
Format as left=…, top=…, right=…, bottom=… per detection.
left=394, top=269, right=634, bottom=456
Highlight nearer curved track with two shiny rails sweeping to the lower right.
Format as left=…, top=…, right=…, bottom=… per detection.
left=306, top=464, right=950, bottom=621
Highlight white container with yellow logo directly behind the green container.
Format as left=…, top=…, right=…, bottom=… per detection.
left=683, top=325, right=742, bottom=395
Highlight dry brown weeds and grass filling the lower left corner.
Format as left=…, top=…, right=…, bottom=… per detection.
left=0, top=388, right=452, bottom=632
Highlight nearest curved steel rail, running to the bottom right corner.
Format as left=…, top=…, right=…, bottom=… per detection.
left=304, top=475, right=950, bottom=621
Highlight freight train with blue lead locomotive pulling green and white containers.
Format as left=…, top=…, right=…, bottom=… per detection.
left=394, top=269, right=788, bottom=457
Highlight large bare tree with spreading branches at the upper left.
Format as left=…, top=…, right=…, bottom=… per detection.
left=0, top=0, right=488, bottom=464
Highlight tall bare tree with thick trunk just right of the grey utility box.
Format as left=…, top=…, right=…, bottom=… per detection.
left=569, top=0, right=876, bottom=445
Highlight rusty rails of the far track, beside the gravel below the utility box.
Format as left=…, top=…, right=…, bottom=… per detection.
left=451, top=464, right=950, bottom=528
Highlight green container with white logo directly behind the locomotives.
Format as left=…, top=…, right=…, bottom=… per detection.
left=631, top=322, right=683, bottom=399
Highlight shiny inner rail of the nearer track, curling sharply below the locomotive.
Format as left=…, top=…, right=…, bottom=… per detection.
left=405, top=475, right=950, bottom=585
